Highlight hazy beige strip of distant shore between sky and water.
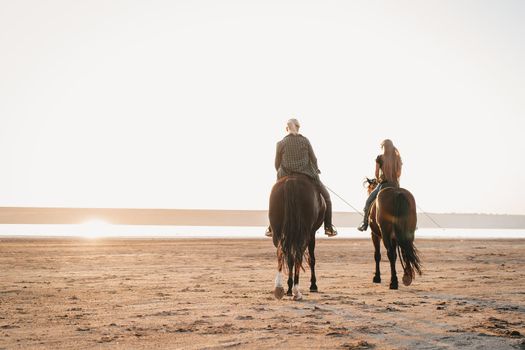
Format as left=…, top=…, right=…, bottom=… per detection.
left=0, top=207, right=525, bottom=229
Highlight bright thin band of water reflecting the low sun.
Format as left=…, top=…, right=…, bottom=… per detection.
left=0, top=221, right=525, bottom=239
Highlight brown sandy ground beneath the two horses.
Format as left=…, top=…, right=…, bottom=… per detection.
left=0, top=239, right=525, bottom=349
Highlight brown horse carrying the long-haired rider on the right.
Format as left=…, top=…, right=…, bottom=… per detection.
left=366, top=178, right=421, bottom=289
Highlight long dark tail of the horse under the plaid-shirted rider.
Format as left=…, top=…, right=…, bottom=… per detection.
left=280, top=179, right=308, bottom=268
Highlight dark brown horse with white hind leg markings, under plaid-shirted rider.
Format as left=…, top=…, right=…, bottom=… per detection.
left=268, top=175, right=326, bottom=300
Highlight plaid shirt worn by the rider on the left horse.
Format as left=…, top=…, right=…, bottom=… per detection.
left=275, top=134, right=321, bottom=182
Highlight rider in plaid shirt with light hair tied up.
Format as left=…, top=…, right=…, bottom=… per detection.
left=266, top=119, right=337, bottom=237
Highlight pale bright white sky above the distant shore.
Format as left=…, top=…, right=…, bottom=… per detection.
left=0, top=0, right=525, bottom=215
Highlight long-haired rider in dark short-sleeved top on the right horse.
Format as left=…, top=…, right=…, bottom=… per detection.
left=357, top=139, right=403, bottom=231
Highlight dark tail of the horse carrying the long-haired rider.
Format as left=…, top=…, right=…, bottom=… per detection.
left=393, top=193, right=421, bottom=279
